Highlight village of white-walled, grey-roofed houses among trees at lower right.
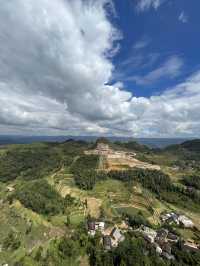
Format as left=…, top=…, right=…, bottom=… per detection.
left=87, top=212, right=200, bottom=260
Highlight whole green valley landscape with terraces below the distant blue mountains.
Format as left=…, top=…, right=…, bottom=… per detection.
left=0, top=139, right=200, bottom=266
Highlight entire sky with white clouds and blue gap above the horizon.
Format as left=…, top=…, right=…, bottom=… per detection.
left=0, top=0, right=200, bottom=138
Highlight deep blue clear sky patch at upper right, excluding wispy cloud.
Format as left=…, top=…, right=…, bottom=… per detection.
left=110, top=0, right=200, bottom=96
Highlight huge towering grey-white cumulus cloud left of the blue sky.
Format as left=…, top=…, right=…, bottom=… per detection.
left=0, top=0, right=126, bottom=133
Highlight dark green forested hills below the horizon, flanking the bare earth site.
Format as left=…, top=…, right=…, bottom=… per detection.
left=0, top=139, right=200, bottom=185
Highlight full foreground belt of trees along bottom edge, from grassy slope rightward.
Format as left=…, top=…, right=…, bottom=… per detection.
left=12, top=221, right=200, bottom=266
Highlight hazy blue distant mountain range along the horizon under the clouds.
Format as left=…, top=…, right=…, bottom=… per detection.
left=0, top=135, right=194, bottom=148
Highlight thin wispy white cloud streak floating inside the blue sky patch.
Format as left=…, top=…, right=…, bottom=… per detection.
left=129, top=56, right=183, bottom=85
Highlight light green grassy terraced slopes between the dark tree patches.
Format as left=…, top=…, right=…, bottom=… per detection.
left=0, top=139, right=200, bottom=265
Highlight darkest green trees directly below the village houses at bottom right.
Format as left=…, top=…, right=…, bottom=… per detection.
left=87, top=232, right=200, bottom=266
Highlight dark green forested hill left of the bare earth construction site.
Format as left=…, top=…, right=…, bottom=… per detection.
left=0, top=140, right=88, bottom=182
